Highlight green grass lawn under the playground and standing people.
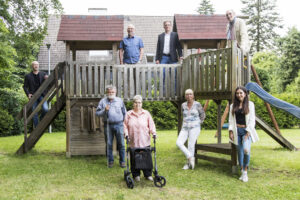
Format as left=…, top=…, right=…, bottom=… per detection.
left=0, top=129, right=300, bottom=200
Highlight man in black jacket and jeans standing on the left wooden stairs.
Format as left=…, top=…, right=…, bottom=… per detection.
left=23, top=61, right=48, bottom=127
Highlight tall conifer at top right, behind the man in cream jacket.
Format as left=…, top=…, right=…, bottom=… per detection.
left=241, top=0, right=283, bottom=52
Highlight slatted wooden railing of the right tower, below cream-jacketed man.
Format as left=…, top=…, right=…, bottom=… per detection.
left=181, top=42, right=250, bottom=99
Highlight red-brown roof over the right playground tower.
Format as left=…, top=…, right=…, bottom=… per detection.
left=174, top=14, right=228, bottom=40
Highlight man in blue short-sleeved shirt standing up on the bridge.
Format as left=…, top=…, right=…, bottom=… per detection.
left=119, top=24, right=144, bottom=65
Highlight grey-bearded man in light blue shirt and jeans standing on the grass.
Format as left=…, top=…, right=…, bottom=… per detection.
left=96, top=85, right=126, bottom=168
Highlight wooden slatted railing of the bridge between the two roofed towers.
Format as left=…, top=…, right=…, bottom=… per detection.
left=65, top=62, right=181, bottom=101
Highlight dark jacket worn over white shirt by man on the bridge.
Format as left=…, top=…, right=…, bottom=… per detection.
left=155, top=32, right=182, bottom=62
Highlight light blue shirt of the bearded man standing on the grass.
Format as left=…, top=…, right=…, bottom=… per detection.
left=96, top=97, right=126, bottom=123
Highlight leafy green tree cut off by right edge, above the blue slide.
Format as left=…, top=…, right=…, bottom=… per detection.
left=279, top=27, right=300, bottom=88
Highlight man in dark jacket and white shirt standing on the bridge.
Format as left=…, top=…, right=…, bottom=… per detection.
left=155, top=21, right=182, bottom=64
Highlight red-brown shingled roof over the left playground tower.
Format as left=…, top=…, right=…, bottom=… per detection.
left=57, top=15, right=124, bottom=41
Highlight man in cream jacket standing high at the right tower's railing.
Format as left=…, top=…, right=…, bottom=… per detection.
left=226, top=10, right=250, bottom=55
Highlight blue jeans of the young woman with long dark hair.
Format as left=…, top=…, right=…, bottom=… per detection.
left=237, top=127, right=251, bottom=169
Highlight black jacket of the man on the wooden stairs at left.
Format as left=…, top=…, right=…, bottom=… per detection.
left=23, top=72, right=47, bottom=96
